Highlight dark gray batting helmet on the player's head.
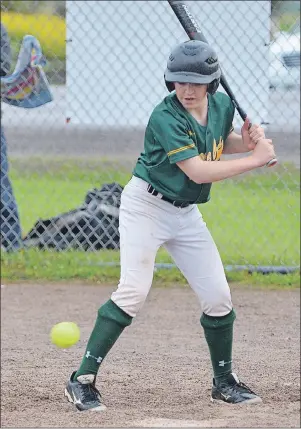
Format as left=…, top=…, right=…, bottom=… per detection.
left=164, top=40, right=221, bottom=94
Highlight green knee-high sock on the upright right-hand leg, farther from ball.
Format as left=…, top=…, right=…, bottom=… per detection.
left=201, top=309, right=236, bottom=380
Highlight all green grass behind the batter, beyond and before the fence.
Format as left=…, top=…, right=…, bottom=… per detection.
left=2, top=155, right=300, bottom=286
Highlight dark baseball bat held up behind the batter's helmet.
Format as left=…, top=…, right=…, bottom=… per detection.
left=167, top=0, right=277, bottom=167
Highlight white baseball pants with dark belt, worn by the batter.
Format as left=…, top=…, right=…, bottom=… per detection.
left=111, top=177, right=232, bottom=317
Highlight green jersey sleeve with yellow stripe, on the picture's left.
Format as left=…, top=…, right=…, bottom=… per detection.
left=150, top=113, right=199, bottom=164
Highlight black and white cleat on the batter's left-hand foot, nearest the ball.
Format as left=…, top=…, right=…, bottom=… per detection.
left=65, top=372, right=106, bottom=411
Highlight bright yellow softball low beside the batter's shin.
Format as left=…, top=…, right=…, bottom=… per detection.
left=50, top=322, right=80, bottom=349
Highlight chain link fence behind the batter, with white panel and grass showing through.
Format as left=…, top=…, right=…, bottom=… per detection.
left=1, top=1, right=300, bottom=269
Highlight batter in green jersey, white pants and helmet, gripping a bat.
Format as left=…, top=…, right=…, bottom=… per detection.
left=65, top=41, right=275, bottom=411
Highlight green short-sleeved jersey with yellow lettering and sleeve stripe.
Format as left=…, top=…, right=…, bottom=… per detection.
left=133, top=92, right=234, bottom=203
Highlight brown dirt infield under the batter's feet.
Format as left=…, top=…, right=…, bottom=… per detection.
left=1, top=285, right=300, bottom=427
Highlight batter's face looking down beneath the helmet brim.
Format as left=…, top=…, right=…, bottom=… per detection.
left=175, top=82, right=207, bottom=109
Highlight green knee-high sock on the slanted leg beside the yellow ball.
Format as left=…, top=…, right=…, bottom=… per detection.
left=74, top=300, right=133, bottom=380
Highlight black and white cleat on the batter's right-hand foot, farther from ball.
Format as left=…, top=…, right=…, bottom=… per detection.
left=211, top=372, right=262, bottom=404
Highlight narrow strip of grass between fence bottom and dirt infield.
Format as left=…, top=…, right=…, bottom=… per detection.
left=1, top=249, right=300, bottom=289
